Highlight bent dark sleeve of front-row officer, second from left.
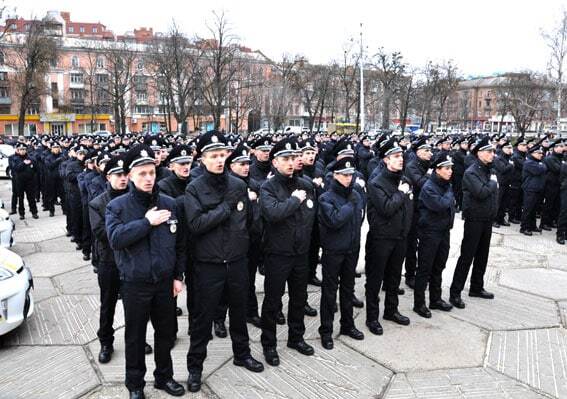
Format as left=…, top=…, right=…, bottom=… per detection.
left=185, top=185, right=231, bottom=235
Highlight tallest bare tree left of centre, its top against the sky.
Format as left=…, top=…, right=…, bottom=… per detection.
left=202, top=12, right=239, bottom=130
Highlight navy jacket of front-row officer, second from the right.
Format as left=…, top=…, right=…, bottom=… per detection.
left=417, top=173, right=455, bottom=233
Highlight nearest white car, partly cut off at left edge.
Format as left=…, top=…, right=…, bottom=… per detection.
left=0, top=248, right=34, bottom=336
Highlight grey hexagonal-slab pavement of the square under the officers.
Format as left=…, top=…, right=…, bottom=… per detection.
left=0, top=180, right=567, bottom=399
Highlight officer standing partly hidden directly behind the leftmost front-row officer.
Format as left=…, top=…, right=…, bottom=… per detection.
left=89, top=157, right=128, bottom=363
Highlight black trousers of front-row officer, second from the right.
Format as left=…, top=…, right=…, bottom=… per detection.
left=413, top=230, right=450, bottom=307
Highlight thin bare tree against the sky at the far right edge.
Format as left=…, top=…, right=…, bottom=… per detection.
left=542, top=10, right=567, bottom=129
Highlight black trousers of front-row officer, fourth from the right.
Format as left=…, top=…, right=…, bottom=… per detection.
left=319, top=249, right=358, bottom=336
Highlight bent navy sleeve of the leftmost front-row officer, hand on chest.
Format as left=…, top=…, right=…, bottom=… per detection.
left=105, top=202, right=152, bottom=250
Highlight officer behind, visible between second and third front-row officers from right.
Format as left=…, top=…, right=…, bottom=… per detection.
left=404, top=137, right=432, bottom=288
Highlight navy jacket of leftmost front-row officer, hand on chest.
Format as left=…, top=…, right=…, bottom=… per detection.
left=105, top=184, right=186, bottom=283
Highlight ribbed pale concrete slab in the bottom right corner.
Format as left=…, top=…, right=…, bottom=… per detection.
left=487, top=328, right=567, bottom=398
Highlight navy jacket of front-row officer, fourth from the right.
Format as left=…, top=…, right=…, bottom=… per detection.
left=318, top=180, right=364, bottom=253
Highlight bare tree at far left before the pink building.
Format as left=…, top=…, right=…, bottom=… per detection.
left=6, top=20, right=58, bottom=136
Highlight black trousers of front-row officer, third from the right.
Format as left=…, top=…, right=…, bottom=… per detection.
left=365, top=238, right=406, bottom=322
